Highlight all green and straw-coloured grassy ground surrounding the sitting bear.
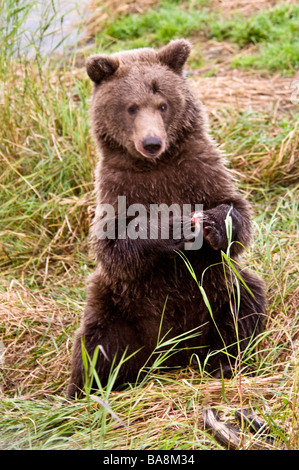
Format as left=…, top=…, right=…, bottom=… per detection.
left=0, top=0, right=299, bottom=450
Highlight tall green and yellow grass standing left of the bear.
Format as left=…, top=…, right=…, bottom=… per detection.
left=0, top=2, right=95, bottom=282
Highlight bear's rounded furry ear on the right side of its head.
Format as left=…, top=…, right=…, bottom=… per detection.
left=157, top=39, right=191, bottom=74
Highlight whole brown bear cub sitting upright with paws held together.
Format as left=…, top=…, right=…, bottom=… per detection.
left=68, top=39, right=265, bottom=396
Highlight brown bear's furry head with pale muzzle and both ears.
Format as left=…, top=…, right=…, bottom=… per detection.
left=86, top=39, right=197, bottom=160
